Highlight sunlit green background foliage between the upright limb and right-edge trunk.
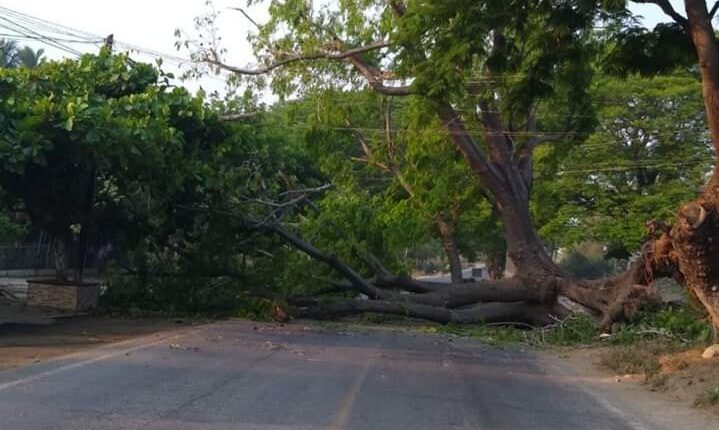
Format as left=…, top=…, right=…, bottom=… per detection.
left=537, top=73, right=711, bottom=257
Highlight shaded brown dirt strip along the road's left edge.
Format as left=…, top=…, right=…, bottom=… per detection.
left=0, top=316, right=190, bottom=370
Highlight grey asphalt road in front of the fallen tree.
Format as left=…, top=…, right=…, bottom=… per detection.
left=0, top=321, right=672, bottom=430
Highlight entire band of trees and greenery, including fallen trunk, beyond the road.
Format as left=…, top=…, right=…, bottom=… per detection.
left=0, top=0, right=719, bottom=406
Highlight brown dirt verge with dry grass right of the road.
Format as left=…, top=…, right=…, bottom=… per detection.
left=558, top=343, right=719, bottom=419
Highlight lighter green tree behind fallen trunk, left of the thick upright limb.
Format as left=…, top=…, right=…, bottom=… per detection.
left=278, top=91, right=504, bottom=283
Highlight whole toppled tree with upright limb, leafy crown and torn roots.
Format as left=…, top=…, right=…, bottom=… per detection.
left=190, top=0, right=719, bottom=327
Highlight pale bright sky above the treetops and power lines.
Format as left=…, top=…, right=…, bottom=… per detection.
left=0, top=0, right=683, bottom=97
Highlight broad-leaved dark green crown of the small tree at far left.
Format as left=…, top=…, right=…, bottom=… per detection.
left=0, top=51, right=179, bottom=240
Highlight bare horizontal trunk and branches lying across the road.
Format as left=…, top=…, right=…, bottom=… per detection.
left=200, top=200, right=668, bottom=328
